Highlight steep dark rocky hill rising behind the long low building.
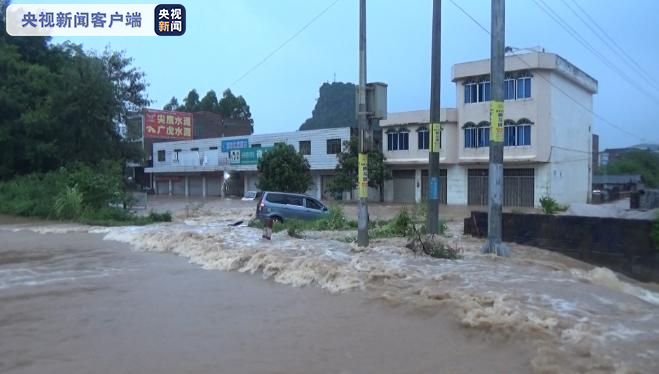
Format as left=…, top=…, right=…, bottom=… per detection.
left=300, top=82, right=357, bottom=130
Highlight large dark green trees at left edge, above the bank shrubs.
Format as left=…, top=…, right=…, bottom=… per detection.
left=0, top=18, right=149, bottom=179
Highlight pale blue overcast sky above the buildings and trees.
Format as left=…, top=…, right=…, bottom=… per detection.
left=25, top=0, right=659, bottom=149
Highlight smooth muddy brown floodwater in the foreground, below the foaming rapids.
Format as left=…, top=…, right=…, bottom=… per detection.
left=0, top=229, right=535, bottom=374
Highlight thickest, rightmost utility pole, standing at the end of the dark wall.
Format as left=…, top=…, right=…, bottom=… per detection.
left=482, top=0, right=508, bottom=256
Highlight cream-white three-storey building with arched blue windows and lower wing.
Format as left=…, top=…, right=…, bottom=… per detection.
left=380, top=52, right=597, bottom=206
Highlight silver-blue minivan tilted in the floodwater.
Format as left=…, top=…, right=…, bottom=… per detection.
left=256, top=191, right=329, bottom=222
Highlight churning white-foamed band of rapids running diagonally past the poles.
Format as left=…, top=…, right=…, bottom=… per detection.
left=6, top=217, right=659, bottom=373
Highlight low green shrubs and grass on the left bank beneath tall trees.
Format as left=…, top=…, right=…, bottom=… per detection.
left=0, top=164, right=171, bottom=226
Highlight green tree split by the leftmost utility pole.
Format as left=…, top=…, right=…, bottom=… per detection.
left=329, top=137, right=391, bottom=202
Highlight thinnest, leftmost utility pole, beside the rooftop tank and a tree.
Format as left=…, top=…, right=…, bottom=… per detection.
left=357, top=0, right=370, bottom=247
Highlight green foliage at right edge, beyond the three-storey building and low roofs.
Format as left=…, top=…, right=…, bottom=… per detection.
left=606, top=149, right=659, bottom=188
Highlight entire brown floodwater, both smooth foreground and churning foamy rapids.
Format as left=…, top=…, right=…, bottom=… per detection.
left=0, top=212, right=659, bottom=373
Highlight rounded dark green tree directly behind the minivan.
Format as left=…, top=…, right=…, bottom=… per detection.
left=256, top=143, right=313, bottom=193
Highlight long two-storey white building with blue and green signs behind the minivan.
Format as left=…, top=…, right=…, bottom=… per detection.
left=145, top=127, right=350, bottom=198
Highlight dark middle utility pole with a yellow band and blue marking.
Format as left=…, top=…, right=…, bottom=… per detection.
left=426, top=0, right=442, bottom=234
